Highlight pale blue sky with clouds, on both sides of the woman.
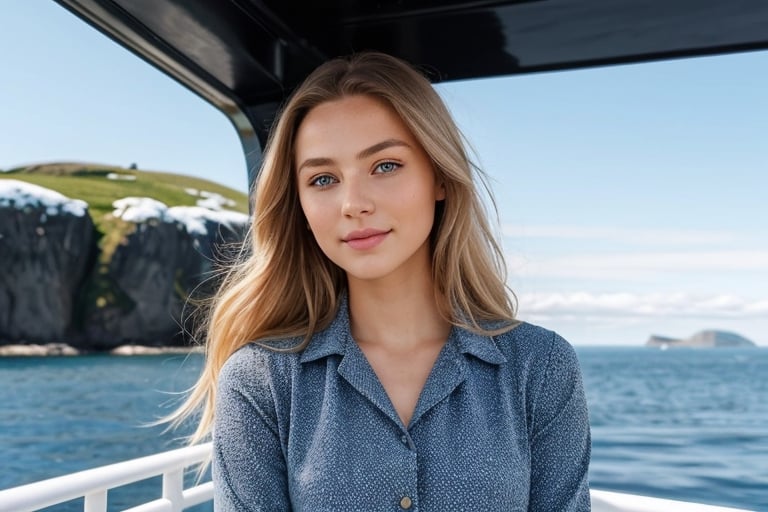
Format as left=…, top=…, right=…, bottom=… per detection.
left=0, top=0, right=768, bottom=345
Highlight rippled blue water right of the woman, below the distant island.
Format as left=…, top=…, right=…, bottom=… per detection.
left=578, top=348, right=768, bottom=511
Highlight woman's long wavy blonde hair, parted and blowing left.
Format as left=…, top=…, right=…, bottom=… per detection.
left=174, top=53, right=515, bottom=442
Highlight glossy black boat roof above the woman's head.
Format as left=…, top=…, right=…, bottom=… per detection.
left=52, top=0, right=768, bottom=180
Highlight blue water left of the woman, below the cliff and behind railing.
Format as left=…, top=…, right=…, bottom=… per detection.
left=0, top=355, right=213, bottom=512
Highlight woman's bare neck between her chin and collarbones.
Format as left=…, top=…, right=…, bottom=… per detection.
left=349, top=273, right=451, bottom=351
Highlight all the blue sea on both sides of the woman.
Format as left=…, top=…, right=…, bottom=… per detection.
left=0, top=347, right=768, bottom=512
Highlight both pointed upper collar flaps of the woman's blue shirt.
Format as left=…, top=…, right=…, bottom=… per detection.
left=300, top=294, right=507, bottom=364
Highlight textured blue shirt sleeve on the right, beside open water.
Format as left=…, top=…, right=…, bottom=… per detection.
left=528, top=335, right=591, bottom=512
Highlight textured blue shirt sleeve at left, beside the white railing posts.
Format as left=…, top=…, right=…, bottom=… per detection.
left=213, top=348, right=291, bottom=512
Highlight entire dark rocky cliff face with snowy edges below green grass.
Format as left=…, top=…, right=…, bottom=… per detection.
left=0, top=179, right=247, bottom=350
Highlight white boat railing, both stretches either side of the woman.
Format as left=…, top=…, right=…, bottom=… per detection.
left=0, top=443, right=748, bottom=512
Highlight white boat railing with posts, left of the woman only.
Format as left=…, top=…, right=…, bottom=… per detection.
left=0, top=443, right=213, bottom=512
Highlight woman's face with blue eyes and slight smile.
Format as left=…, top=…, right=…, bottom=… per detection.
left=295, top=95, right=445, bottom=281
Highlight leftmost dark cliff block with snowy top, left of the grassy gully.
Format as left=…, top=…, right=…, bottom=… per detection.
left=0, top=181, right=96, bottom=343
